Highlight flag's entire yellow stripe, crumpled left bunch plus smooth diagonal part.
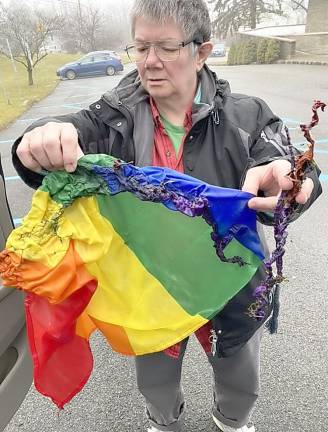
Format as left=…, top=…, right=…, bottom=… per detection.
left=7, top=190, right=207, bottom=354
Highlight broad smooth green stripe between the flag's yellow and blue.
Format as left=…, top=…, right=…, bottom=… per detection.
left=97, top=193, right=261, bottom=319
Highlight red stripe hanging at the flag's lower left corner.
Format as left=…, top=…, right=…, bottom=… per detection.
left=25, top=280, right=97, bottom=408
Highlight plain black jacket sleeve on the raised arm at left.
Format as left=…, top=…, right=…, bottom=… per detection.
left=12, top=110, right=110, bottom=189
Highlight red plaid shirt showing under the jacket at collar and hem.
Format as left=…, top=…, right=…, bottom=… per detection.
left=150, top=98, right=212, bottom=358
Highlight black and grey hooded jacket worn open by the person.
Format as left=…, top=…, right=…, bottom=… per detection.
left=13, top=67, right=321, bottom=356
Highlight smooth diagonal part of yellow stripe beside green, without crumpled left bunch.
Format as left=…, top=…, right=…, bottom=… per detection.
left=65, top=198, right=207, bottom=354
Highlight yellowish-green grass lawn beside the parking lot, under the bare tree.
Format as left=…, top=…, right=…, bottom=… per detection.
left=0, top=53, right=128, bottom=129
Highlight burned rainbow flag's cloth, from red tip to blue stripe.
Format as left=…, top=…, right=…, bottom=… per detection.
left=0, top=155, right=264, bottom=407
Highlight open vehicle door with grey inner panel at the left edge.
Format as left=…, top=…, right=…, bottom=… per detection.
left=0, top=160, right=32, bottom=431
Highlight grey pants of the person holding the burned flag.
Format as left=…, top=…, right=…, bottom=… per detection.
left=135, top=328, right=263, bottom=432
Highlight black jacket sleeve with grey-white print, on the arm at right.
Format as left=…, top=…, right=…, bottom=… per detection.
left=243, top=99, right=322, bottom=225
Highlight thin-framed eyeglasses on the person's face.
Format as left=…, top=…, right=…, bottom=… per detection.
left=125, top=39, right=202, bottom=63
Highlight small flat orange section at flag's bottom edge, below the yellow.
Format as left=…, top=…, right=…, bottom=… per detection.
left=90, top=317, right=135, bottom=355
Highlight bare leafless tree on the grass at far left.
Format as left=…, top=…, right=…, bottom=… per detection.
left=0, top=3, right=60, bottom=85
